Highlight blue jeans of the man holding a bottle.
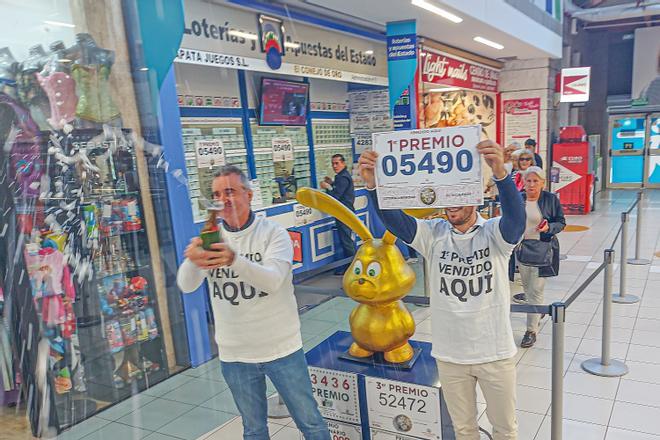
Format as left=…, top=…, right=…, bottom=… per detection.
left=220, top=349, right=330, bottom=440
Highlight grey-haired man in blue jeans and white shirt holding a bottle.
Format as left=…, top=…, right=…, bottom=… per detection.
left=177, top=165, right=330, bottom=440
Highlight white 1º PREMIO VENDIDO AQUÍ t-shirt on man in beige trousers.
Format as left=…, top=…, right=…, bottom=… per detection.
left=412, top=216, right=517, bottom=364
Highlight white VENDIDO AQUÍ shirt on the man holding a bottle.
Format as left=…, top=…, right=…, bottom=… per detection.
left=177, top=217, right=302, bottom=363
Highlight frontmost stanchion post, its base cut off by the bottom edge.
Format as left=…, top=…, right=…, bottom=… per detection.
left=550, top=303, right=566, bottom=440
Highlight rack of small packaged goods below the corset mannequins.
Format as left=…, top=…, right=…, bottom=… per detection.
left=16, top=129, right=167, bottom=428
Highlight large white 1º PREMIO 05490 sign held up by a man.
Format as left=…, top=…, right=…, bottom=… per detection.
left=373, top=125, right=483, bottom=209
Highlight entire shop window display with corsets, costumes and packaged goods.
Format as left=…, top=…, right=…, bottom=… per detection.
left=0, top=34, right=168, bottom=436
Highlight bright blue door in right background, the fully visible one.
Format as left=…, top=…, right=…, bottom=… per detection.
left=607, top=115, right=646, bottom=188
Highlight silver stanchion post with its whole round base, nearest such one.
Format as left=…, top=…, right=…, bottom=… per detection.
left=582, top=249, right=628, bottom=377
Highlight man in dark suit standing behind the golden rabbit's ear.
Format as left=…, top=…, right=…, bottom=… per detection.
left=321, top=154, right=355, bottom=275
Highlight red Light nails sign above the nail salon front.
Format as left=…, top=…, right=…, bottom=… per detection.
left=421, top=51, right=500, bottom=92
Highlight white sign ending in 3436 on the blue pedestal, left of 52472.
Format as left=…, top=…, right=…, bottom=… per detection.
left=309, top=367, right=361, bottom=425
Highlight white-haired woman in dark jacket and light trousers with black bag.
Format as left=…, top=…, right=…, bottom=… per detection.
left=509, top=166, right=566, bottom=348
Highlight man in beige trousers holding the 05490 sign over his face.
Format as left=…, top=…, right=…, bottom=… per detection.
left=359, top=137, right=525, bottom=440
